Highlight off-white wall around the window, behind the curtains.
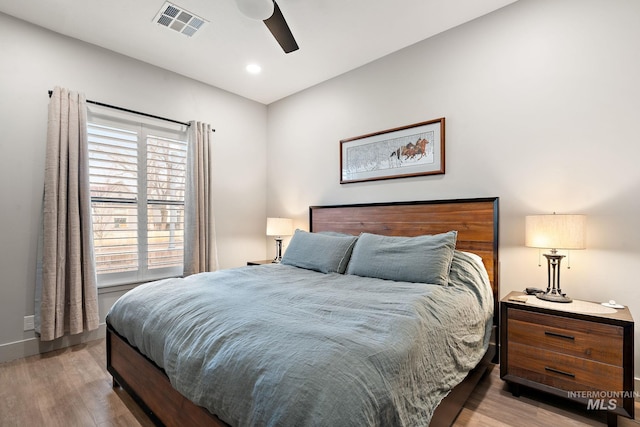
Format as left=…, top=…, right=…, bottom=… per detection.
left=0, top=14, right=267, bottom=362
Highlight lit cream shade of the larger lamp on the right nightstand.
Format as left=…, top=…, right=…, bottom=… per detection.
left=525, top=214, right=587, bottom=249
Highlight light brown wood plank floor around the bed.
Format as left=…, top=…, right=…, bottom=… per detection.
left=0, top=340, right=640, bottom=427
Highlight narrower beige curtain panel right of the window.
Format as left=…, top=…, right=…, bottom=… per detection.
left=184, top=121, right=218, bottom=276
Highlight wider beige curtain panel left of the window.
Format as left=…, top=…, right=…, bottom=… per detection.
left=36, top=87, right=99, bottom=341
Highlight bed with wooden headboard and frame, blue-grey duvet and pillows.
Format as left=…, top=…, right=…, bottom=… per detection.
left=107, top=198, right=498, bottom=426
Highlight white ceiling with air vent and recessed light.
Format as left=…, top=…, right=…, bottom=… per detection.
left=0, top=0, right=516, bottom=104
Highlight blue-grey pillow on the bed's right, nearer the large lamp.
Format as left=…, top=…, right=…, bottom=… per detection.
left=347, top=231, right=458, bottom=286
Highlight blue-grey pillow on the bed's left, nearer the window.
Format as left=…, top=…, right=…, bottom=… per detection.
left=281, top=230, right=358, bottom=273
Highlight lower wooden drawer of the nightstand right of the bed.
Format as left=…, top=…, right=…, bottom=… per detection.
left=508, top=342, right=623, bottom=391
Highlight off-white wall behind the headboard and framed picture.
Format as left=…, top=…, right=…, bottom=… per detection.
left=267, top=0, right=640, bottom=376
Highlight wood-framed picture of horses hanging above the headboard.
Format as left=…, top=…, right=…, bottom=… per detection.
left=340, top=117, right=444, bottom=184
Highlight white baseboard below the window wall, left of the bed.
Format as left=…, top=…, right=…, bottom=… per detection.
left=0, top=323, right=107, bottom=363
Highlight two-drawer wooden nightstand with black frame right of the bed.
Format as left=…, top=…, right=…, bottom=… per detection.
left=500, top=292, right=634, bottom=426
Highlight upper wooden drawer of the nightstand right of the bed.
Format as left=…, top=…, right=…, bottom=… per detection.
left=508, top=309, right=624, bottom=366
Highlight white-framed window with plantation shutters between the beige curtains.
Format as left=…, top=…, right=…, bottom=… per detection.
left=87, top=117, right=187, bottom=286
